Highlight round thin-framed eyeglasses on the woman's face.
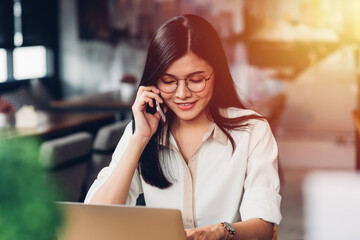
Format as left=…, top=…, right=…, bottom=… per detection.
left=157, top=72, right=214, bottom=93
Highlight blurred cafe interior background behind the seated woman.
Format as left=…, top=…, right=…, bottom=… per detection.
left=0, top=0, right=360, bottom=240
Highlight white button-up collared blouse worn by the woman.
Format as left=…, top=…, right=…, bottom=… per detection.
left=85, top=108, right=282, bottom=228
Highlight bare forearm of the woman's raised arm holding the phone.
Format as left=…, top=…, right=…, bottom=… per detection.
left=90, top=135, right=149, bottom=204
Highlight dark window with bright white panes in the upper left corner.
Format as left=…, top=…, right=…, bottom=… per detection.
left=0, top=0, right=58, bottom=84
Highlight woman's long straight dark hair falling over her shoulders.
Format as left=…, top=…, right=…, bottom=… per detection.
left=133, top=14, right=262, bottom=189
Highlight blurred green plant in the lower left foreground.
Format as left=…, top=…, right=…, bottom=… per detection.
left=0, top=139, right=61, bottom=240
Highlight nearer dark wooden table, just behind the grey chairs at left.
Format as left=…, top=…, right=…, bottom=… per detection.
left=0, top=111, right=115, bottom=140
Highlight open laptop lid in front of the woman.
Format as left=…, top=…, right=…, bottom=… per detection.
left=56, top=202, right=185, bottom=240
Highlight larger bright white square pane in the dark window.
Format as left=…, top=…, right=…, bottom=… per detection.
left=13, top=46, right=47, bottom=80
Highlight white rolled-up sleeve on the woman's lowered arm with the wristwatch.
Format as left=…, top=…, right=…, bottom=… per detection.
left=240, top=120, right=282, bottom=224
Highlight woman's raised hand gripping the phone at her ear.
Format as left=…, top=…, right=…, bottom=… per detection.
left=132, top=86, right=166, bottom=140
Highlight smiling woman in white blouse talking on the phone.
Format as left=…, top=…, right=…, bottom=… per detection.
left=85, top=15, right=281, bottom=239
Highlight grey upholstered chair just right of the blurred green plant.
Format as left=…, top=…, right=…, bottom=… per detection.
left=39, top=132, right=92, bottom=202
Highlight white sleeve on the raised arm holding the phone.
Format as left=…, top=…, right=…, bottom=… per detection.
left=84, top=122, right=143, bottom=206
